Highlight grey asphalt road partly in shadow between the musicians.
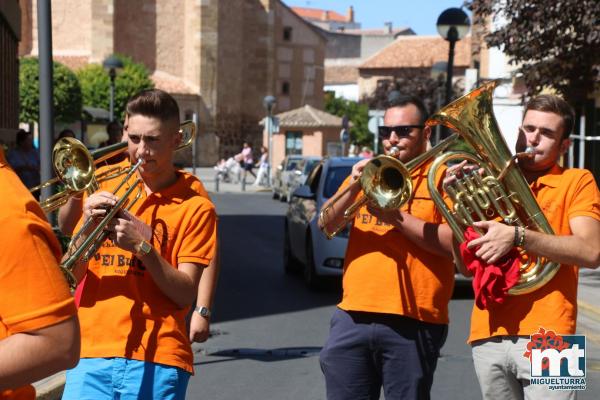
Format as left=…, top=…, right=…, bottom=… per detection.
left=187, top=193, right=600, bottom=400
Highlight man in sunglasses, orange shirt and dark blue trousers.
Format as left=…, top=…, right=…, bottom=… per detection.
left=320, top=97, right=454, bottom=400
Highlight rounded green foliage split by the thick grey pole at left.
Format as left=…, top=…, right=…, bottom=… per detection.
left=19, top=57, right=81, bottom=123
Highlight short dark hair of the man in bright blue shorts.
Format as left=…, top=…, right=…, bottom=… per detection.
left=125, top=89, right=179, bottom=126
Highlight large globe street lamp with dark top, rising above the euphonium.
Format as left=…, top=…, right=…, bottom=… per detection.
left=436, top=8, right=471, bottom=104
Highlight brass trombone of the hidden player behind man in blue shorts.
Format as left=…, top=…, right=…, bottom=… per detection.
left=30, top=121, right=196, bottom=213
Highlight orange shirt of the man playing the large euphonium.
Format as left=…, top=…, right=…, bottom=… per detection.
left=468, top=166, right=600, bottom=343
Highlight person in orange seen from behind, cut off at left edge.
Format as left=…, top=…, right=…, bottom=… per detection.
left=0, top=147, right=80, bottom=400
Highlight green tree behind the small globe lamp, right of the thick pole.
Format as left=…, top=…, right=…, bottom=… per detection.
left=77, top=55, right=154, bottom=119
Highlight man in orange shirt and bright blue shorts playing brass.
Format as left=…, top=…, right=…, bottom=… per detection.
left=58, top=89, right=216, bottom=399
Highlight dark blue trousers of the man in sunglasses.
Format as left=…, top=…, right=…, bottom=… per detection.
left=319, top=309, right=448, bottom=400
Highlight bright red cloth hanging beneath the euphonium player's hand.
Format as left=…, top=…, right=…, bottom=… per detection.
left=460, top=227, right=520, bottom=310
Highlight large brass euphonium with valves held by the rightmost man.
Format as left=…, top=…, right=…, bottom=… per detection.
left=426, top=82, right=560, bottom=295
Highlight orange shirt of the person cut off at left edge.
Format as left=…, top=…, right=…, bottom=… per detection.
left=0, top=149, right=77, bottom=400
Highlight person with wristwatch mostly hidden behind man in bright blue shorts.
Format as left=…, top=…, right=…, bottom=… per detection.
left=57, top=122, right=220, bottom=343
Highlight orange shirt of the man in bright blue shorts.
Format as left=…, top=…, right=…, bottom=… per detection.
left=74, top=166, right=216, bottom=372
